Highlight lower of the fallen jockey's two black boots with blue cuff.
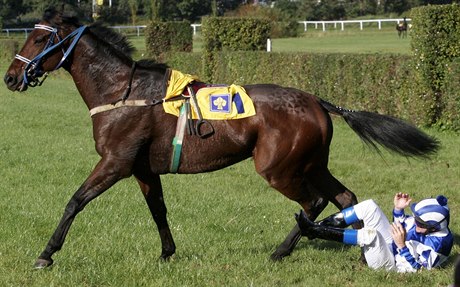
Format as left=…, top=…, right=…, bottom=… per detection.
left=295, top=210, right=358, bottom=245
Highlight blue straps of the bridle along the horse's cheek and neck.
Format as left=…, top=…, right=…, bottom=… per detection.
left=24, top=26, right=87, bottom=85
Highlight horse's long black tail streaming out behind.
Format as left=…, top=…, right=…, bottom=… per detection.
left=319, top=99, right=440, bottom=157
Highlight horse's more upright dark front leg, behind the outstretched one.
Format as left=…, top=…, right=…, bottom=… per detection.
left=134, top=170, right=176, bottom=260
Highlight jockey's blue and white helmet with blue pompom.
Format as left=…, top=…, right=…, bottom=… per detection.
left=411, top=195, right=450, bottom=231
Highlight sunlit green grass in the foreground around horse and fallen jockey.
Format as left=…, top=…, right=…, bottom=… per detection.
left=0, top=72, right=460, bottom=286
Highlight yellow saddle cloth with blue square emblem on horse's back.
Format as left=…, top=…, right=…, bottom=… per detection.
left=163, top=70, right=256, bottom=120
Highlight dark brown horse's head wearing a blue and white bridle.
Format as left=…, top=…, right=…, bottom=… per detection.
left=4, top=8, right=86, bottom=92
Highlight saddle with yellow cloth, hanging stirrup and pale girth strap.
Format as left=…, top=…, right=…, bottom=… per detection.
left=163, top=70, right=256, bottom=173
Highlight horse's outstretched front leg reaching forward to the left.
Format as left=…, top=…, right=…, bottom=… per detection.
left=35, top=158, right=130, bottom=268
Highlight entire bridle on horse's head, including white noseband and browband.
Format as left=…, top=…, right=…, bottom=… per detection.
left=14, top=24, right=87, bottom=87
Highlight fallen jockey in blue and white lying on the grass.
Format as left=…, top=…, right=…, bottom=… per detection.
left=296, top=193, right=453, bottom=272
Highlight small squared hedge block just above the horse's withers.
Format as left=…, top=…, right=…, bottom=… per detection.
left=145, top=21, right=193, bottom=61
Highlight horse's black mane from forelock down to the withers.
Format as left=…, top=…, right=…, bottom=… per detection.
left=43, top=8, right=168, bottom=69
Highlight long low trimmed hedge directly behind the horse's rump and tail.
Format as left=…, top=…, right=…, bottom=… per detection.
left=210, top=53, right=418, bottom=121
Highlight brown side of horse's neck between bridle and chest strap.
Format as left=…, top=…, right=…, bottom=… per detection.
left=68, top=38, right=131, bottom=109
